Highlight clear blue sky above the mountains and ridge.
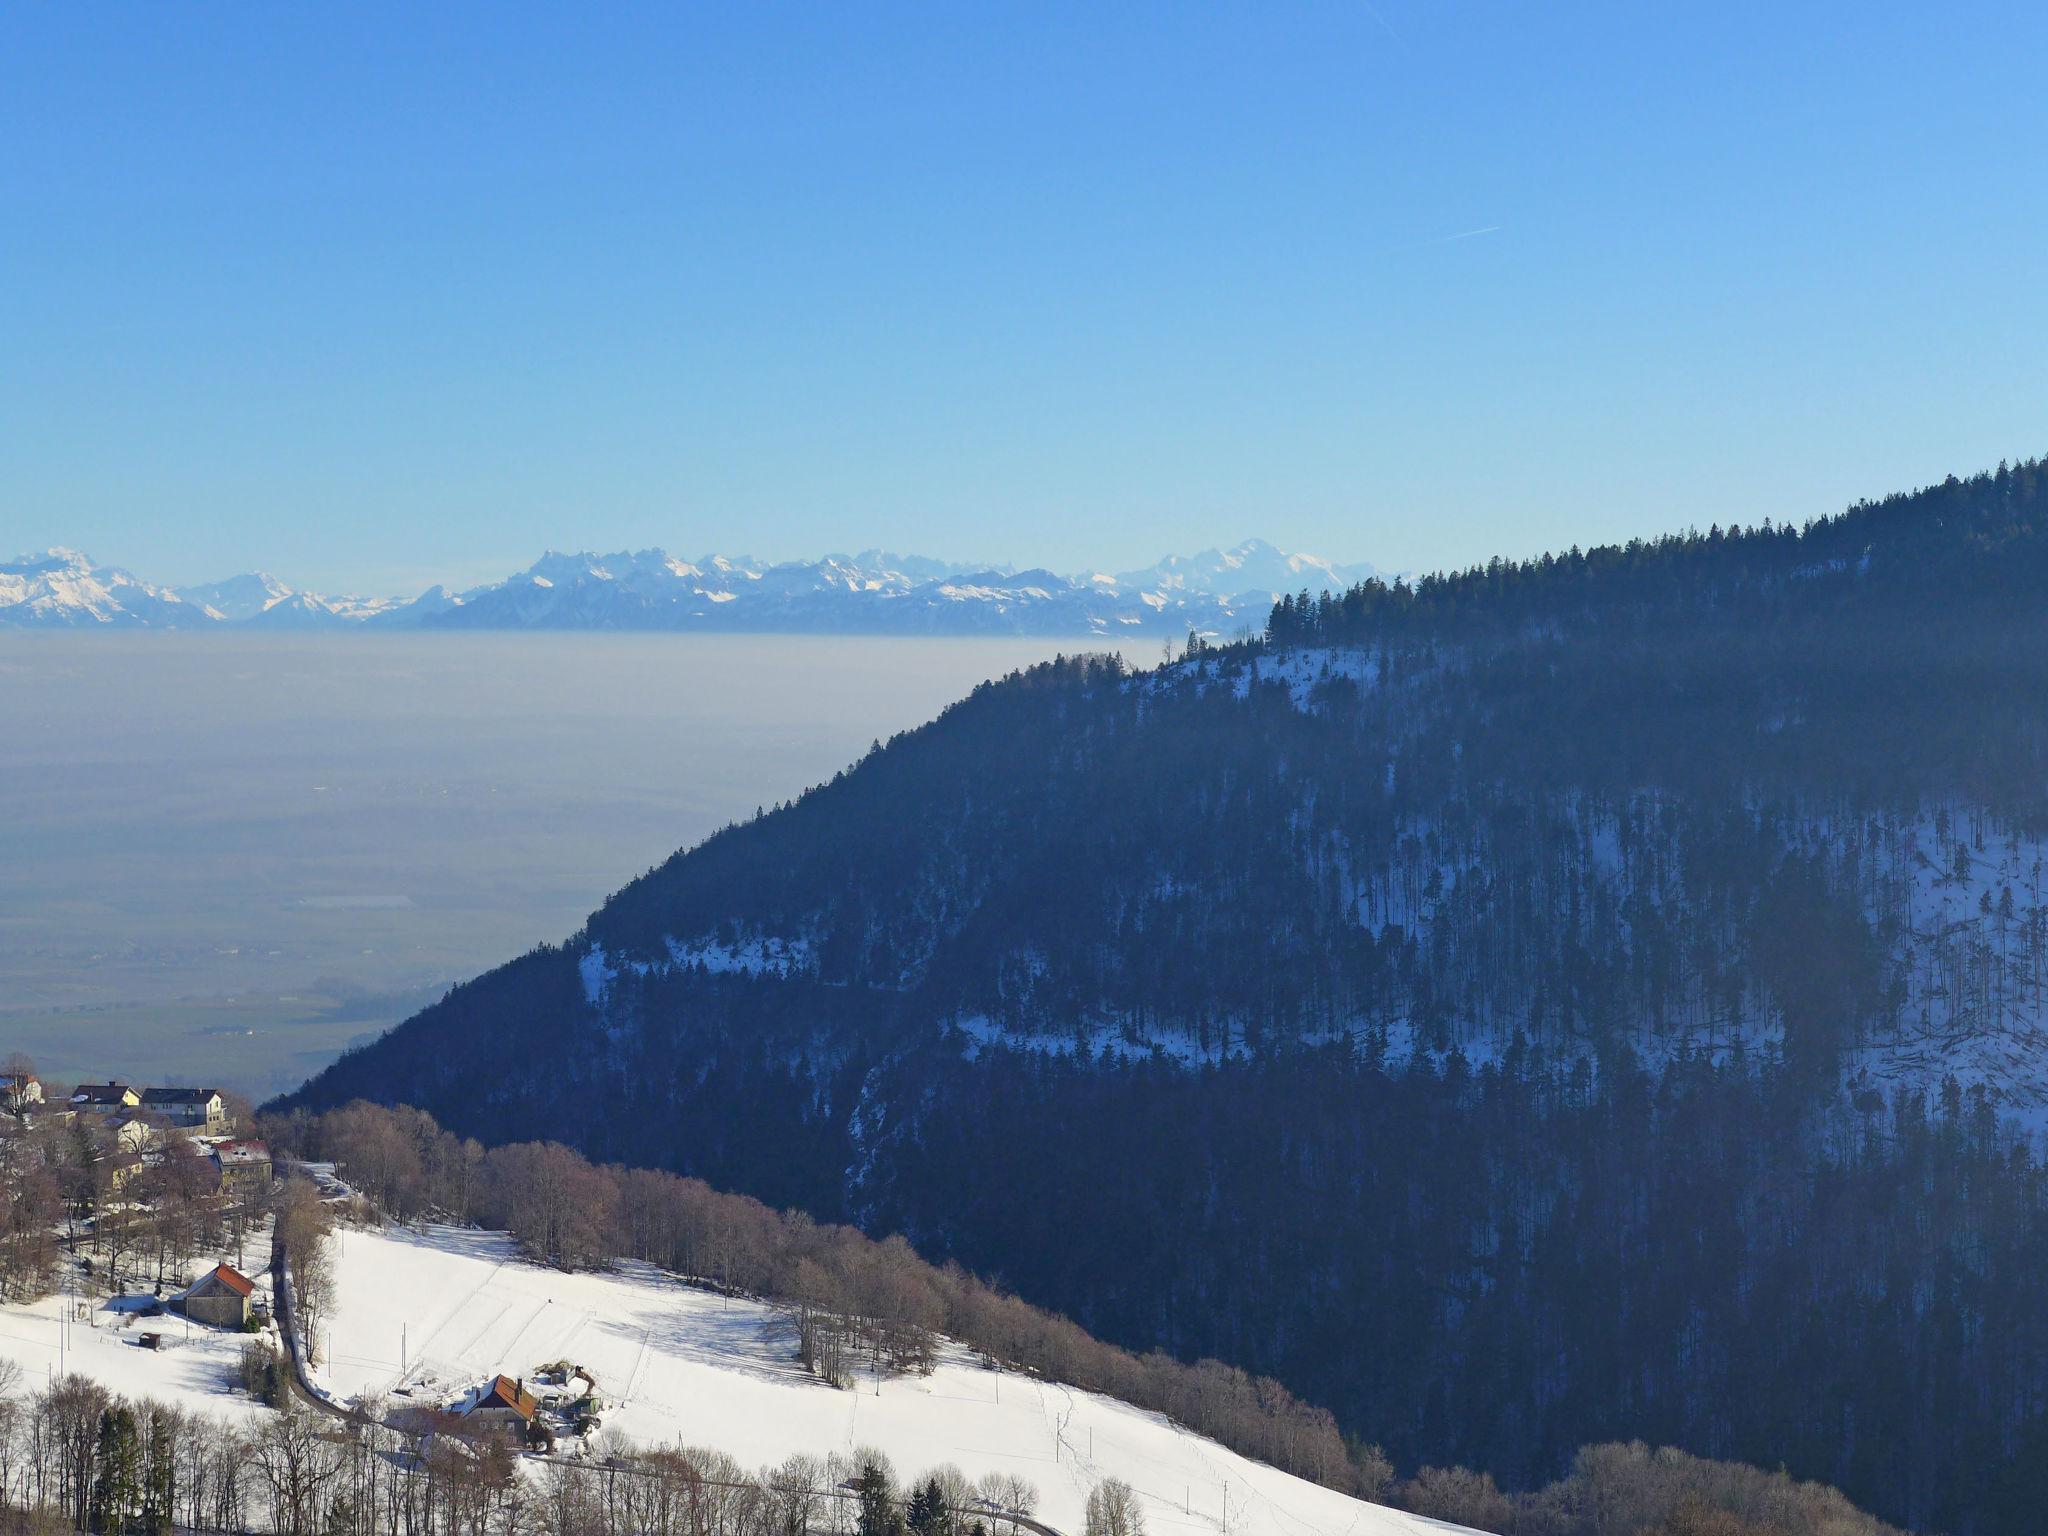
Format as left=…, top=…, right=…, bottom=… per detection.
left=0, top=0, right=2048, bottom=590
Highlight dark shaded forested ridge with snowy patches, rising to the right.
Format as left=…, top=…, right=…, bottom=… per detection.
left=284, top=461, right=2048, bottom=1532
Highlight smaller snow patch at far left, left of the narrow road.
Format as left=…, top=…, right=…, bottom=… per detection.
left=0, top=1233, right=270, bottom=1419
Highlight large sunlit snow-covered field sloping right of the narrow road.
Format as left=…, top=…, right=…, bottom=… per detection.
left=315, top=1227, right=1474, bottom=1536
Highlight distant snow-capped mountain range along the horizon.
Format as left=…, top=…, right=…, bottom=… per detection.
left=0, top=539, right=1374, bottom=635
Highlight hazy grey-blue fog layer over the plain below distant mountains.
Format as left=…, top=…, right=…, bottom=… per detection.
left=0, top=633, right=1138, bottom=1092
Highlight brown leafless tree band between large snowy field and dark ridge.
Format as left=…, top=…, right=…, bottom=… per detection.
left=262, top=1102, right=1378, bottom=1491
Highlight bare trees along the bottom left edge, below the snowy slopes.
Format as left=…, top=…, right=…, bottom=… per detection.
left=0, top=1368, right=1081, bottom=1536
